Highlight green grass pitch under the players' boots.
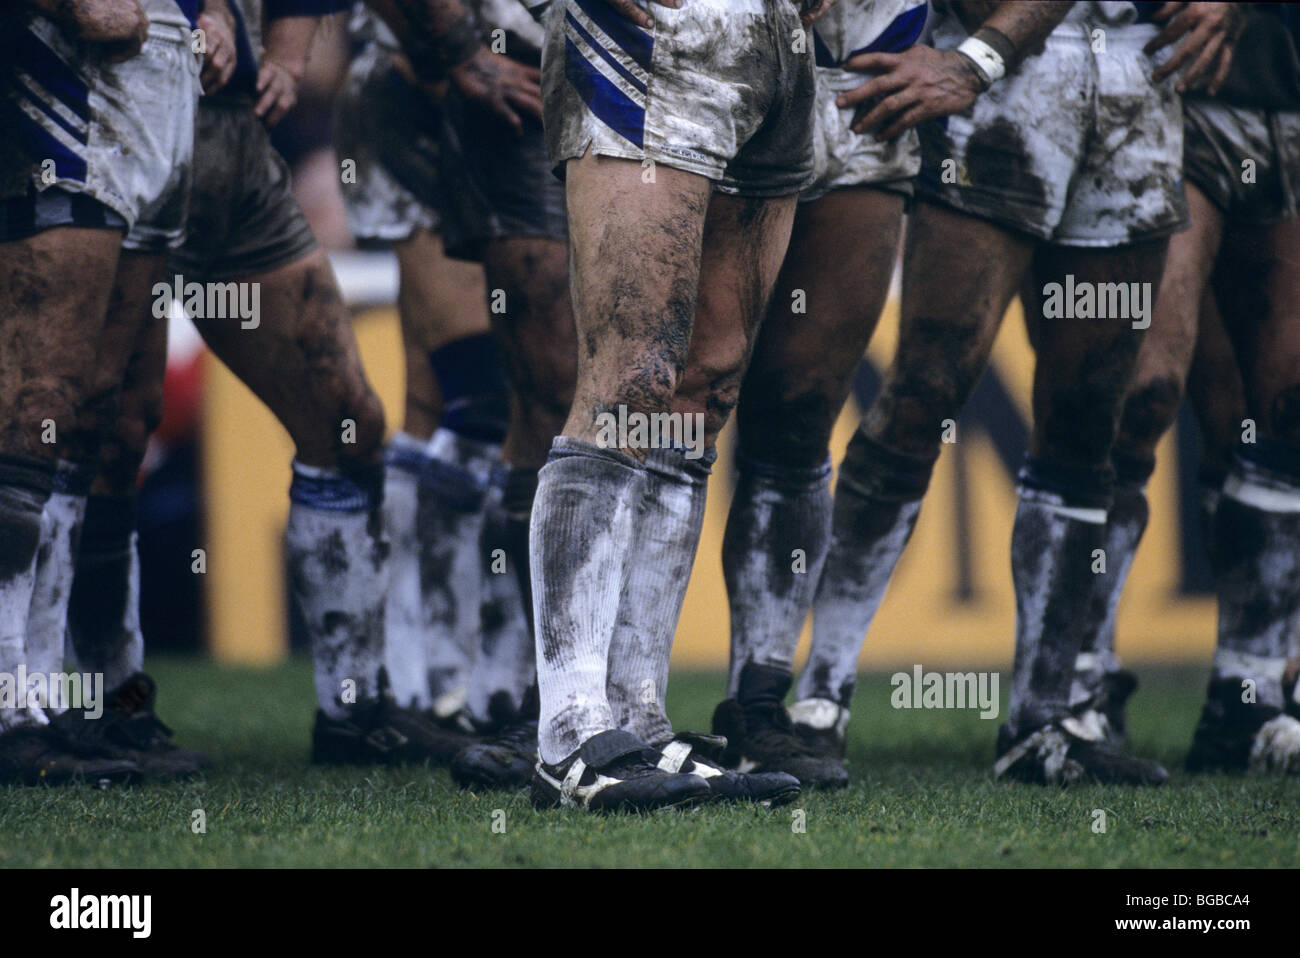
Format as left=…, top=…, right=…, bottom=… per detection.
left=0, top=660, right=1300, bottom=868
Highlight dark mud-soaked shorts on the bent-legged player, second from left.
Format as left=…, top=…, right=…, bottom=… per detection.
left=172, top=99, right=316, bottom=282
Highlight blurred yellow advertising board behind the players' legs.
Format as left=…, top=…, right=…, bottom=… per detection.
left=203, top=300, right=1214, bottom=668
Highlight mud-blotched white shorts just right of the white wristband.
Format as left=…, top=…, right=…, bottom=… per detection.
left=917, top=16, right=1187, bottom=247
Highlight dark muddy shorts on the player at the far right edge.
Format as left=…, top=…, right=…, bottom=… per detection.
left=1183, top=97, right=1300, bottom=226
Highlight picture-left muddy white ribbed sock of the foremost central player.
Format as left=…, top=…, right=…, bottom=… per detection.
left=529, top=435, right=646, bottom=763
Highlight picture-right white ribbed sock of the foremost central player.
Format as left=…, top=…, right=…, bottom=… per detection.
left=606, top=448, right=718, bottom=745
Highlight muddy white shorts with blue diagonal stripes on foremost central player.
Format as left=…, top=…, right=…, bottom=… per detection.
left=542, top=0, right=815, bottom=196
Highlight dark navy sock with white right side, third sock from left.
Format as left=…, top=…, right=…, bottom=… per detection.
left=66, top=495, right=144, bottom=689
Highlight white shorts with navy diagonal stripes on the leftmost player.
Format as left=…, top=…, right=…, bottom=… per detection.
left=0, top=16, right=199, bottom=252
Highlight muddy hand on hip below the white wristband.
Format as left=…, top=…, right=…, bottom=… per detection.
left=836, top=45, right=984, bottom=139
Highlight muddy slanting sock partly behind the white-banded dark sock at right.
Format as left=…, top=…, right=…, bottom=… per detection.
left=1070, top=456, right=1156, bottom=707
